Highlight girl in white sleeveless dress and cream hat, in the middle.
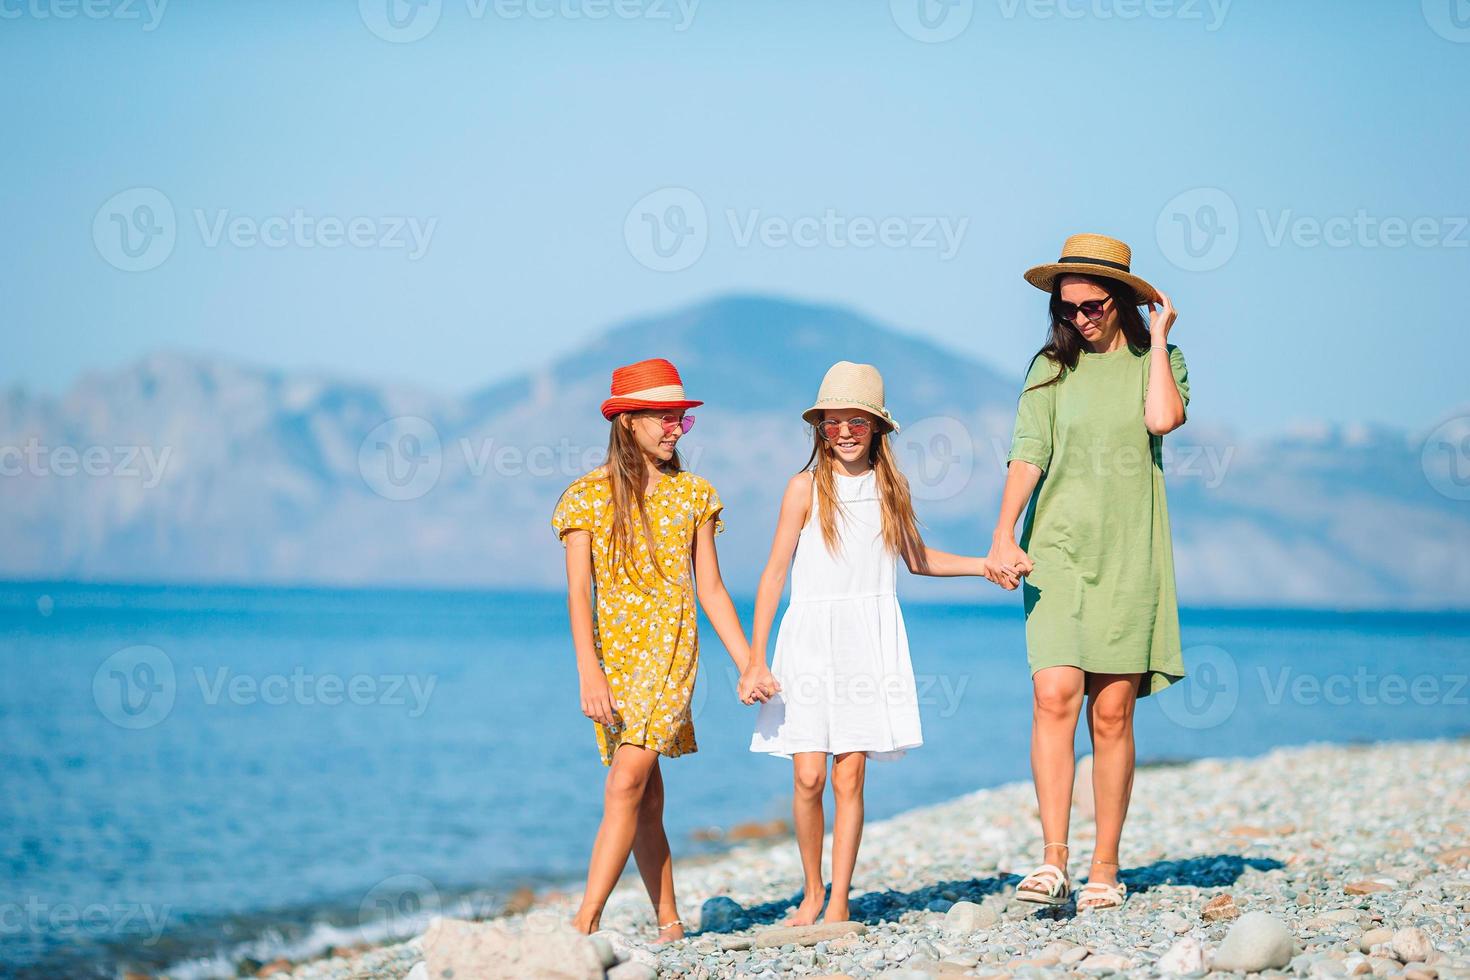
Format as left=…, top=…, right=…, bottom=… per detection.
left=750, top=361, right=985, bottom=926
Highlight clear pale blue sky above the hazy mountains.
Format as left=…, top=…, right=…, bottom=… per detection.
left=0, top=0, right=1470, bottom=433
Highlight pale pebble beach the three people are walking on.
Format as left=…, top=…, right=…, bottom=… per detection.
left=246, top=741, right=1470, bottom=980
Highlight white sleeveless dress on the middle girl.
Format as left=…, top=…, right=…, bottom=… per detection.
left=750, top=470, right=923, bottom=760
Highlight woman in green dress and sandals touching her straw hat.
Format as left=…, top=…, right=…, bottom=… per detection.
left=986, top=235, right=1189, bottom=911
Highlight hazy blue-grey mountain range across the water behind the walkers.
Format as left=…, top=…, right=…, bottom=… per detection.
left=0, top=297, right=1470, bottom=608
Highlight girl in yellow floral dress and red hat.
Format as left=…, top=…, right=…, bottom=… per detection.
left=551, top=359, right=778, bottom=942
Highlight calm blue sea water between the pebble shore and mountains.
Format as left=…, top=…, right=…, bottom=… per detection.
left=0, top=583, right=1470, bottom=976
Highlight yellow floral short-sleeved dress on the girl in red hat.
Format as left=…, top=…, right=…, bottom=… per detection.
left=551, top=469, right=725, bottom=765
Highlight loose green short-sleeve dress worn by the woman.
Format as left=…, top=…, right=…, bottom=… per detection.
left=1007, top=347, right=1189, bottom=696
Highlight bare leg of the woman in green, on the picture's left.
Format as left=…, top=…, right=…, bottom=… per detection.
left=1030, top=667, right=1086, bottom=887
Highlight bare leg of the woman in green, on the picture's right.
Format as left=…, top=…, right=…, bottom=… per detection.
left=1088, top=674, right=1142, bottom=905
